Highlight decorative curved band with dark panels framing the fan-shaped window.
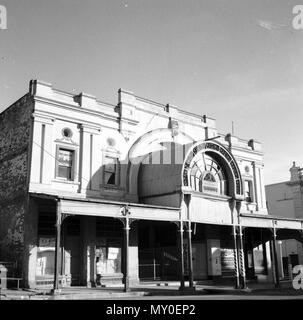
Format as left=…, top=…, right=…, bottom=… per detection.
left=182, top=141, right=243, bottom=199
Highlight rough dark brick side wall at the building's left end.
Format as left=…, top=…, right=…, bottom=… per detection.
left=0, top=95, right=32, bottom=275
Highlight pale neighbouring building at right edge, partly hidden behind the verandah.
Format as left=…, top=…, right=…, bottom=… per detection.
left=265, top=162, right=303, bottom=278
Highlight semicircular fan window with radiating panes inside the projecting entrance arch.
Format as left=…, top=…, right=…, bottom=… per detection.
left=190, top=152, right=227, bottom=195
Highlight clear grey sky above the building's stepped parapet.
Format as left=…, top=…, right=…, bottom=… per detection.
left=0, top=0, right=303, bottom=184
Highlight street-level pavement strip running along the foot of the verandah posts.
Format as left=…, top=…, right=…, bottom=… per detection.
left=0, top=281, right=303, bottom=300
